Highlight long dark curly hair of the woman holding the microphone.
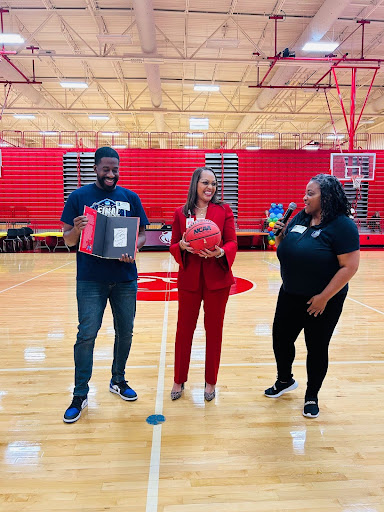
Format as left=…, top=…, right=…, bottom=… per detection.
left=310, top=174, right=351, bottom=222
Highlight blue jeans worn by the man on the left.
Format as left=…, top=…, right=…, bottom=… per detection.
left=73, top=281, right=137, bottom=396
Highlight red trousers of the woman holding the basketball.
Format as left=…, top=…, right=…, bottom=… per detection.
left=174, top=278, right=231, bottom=385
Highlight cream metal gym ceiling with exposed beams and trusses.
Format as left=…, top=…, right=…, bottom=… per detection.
left=0, top=0, right=384, bottom=137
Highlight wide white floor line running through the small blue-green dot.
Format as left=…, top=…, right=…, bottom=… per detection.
left=145, top=255, right=172, bottom=512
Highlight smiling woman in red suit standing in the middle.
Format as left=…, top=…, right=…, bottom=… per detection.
left=170, top=167, right=237, bottom=401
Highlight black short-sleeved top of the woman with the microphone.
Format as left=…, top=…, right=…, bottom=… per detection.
left=277, top=210, right=360, bottom=297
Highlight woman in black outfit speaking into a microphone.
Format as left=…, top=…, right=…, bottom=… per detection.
left=265, top=174, right=360, bottom=418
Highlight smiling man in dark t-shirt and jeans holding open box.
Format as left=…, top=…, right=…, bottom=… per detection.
left=61, top=147, right=149, bottom=423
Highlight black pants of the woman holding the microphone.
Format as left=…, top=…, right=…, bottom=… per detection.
left=272, top=287, right=346, bottom=398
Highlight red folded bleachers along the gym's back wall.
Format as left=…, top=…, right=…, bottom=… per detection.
left=0, top=148, right=384, bottom=228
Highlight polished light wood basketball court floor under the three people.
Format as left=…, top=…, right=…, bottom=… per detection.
left=0, top=251, right=384, bottom=512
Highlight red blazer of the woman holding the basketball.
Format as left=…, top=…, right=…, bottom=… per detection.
left=169, top=203, right=237, bottom=291
